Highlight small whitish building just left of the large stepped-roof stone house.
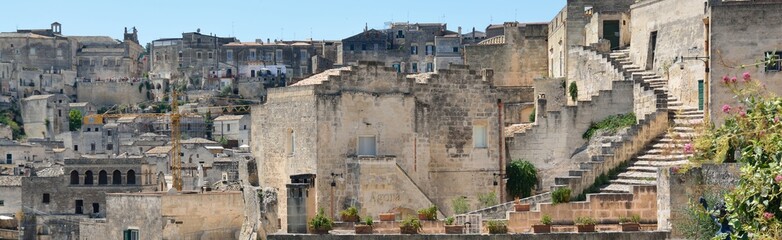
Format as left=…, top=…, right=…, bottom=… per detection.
left=212, top=115, right=252, bottom=146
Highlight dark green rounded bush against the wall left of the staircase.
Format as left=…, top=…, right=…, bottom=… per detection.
left=507, top=160, right=538, bottom=198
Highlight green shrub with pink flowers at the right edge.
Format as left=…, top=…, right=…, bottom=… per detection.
left=685, top=68, right=782, bottom=239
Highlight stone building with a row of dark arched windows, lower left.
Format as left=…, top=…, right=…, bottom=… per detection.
left=22, top=157, right=158, bottom=239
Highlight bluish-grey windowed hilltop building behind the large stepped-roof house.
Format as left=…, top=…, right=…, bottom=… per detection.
left=339, top=23, right=463, bottom=73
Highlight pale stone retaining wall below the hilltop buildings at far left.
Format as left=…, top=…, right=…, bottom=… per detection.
left=76, top=82, right=147, bottom=107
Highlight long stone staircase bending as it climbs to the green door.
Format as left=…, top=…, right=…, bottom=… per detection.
left=601, top=50, right=703, bottom=193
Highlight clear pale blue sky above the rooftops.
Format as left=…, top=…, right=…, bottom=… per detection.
left=0, top=0, right=566, bottom=45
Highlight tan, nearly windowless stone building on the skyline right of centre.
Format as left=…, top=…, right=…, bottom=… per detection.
left=466, top=22, right=548, bottom=87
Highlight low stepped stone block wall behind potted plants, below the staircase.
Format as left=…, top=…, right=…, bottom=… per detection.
left=508, top=186, right=657, bottom=233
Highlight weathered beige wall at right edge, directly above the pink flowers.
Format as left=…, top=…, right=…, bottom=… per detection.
left=707, top=2, right=782, bottom=124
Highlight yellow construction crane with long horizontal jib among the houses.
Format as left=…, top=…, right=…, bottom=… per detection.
left=84, top=88, right=252, bottom=192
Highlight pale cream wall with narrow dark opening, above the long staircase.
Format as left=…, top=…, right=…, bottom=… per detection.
left=630, top=0, right=712, bottom=107
